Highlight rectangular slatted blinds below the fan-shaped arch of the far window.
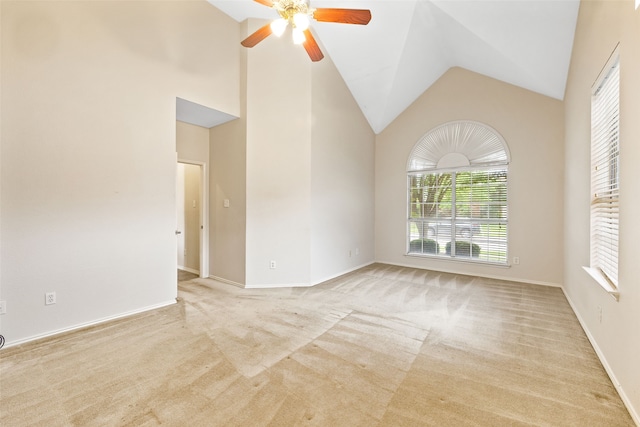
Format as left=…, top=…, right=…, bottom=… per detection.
left=408, top=170, right=507, bottom=264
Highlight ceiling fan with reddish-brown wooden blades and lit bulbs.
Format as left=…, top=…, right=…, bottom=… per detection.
left=240, top=0, right=371, bottom=62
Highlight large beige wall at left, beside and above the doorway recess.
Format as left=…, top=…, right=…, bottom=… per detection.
left=0, top=1, right=240, bottom=344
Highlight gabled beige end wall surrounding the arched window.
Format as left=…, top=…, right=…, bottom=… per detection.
left=375, top=68, right=564, bottom=286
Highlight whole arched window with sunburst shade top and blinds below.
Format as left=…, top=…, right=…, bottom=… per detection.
left=407, top=121, right=510, bottom=264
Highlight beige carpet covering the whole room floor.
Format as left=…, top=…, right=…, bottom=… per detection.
left=0, top=264, right=634, bottom=427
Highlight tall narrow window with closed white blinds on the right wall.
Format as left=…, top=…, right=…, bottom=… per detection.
left=590, top=55, right=620, bottom=287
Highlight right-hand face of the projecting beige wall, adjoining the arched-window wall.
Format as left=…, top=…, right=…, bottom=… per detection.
left=311, top=49, right=375, bottom=284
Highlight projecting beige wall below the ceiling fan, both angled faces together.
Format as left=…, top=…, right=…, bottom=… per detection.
left=246, top=20, right=374, bottom=287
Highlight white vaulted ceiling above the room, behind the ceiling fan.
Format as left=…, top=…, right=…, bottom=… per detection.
left=208, top=0, right=580, bottom=133
